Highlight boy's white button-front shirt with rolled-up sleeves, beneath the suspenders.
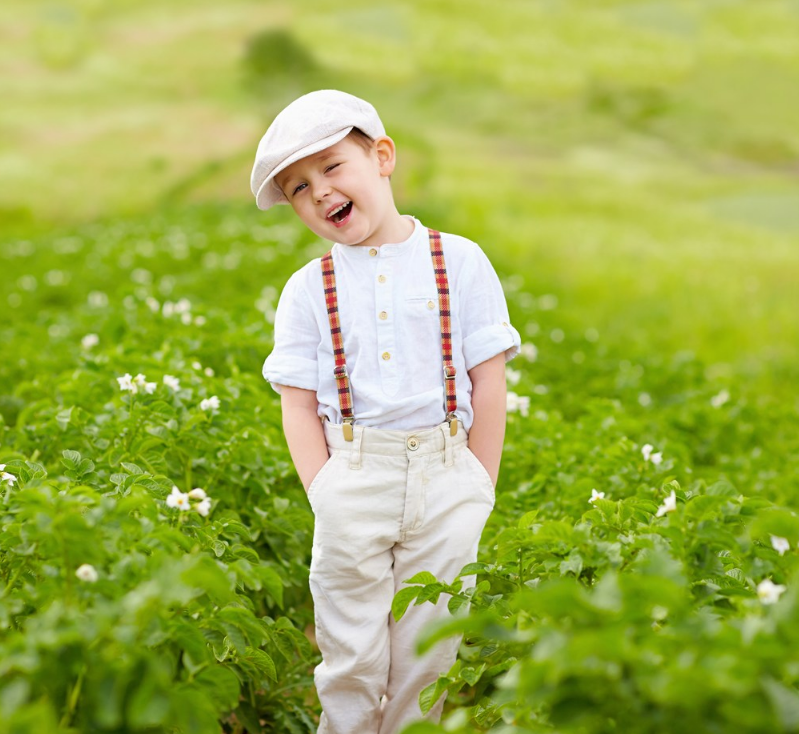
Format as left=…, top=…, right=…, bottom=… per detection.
left=263, top=217, right=521, bottom=431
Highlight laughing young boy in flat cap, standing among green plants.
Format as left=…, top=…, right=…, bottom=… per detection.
left=251, top=90, right=520, bottom=734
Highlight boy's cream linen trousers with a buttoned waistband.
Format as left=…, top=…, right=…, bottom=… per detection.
left=308, top=422, right=494, bottom=734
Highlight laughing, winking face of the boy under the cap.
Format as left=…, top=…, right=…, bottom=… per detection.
left=275, top=136, right=396, bottom=245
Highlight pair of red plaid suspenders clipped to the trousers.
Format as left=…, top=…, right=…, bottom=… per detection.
left=322, top=229, right=458, bottom=441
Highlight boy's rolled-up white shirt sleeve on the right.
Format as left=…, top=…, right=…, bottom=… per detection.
left=459, top=245, right=521, bottom=370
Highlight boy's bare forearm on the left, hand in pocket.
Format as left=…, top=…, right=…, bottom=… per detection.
left=280, top=386, right=330, bottom=491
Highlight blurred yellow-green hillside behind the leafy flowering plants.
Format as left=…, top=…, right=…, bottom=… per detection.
left=0, top=0, right=799, bottom=408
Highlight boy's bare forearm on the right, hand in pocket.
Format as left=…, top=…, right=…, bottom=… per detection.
left=469, top=352, right=507, bottom=486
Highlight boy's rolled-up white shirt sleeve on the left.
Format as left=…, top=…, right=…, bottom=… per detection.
left=262, top=270, right=320, bottom=393
